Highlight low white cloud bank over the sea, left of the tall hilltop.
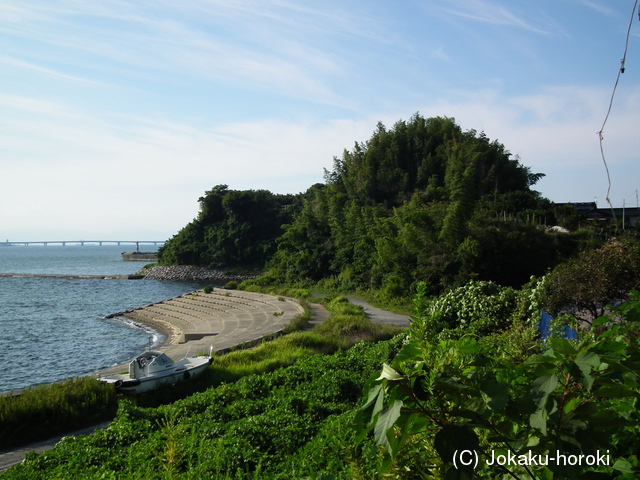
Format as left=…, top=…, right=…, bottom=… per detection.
left=0, top=90, right=373, bottom=236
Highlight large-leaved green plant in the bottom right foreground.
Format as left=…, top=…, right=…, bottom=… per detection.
left=357, top=292, right=640, bottom=480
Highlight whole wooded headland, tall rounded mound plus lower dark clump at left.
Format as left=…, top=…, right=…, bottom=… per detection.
left=161, top=114, right=573, bottom=296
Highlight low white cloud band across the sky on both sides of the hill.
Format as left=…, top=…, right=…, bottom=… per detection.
left=0, top=81, right=640, bottom=236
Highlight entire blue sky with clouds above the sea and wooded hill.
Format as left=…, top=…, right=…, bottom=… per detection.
left=0, top=0, right=640, bottom=241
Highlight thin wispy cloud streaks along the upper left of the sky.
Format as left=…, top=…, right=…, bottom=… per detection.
left=0, top=0, right=390, bottom=105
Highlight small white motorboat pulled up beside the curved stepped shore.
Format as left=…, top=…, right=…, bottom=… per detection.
left=100, top=350, right=213, bottom=393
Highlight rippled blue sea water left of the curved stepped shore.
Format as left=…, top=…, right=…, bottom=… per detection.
left=0, top=245, right=203, bottom=393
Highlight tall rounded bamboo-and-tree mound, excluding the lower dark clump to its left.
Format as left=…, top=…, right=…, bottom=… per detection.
left=271, top=114, right=559, bottom=296
